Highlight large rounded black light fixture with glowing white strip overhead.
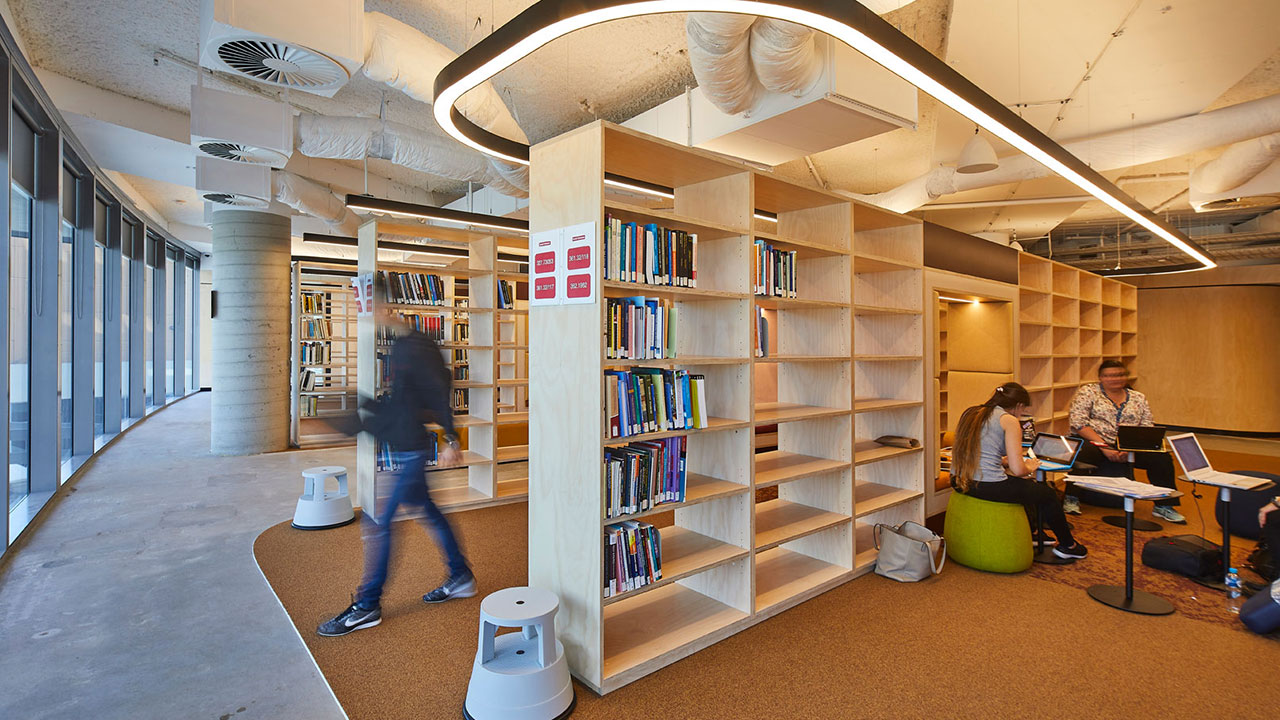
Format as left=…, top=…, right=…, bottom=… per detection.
left=431, top=0, right=1216, bottom=269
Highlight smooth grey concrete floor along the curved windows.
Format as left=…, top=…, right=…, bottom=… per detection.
left=0, top=393, right=355, bottom=720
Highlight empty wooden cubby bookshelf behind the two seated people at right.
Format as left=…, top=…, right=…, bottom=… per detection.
left=1018, top=252, right=1138, bottom=434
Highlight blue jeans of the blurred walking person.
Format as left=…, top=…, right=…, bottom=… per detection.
left=356, top=451, right=471, bottom=609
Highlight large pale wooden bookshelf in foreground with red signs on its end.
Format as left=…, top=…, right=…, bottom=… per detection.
left=529, top=122, right=924, bottom=693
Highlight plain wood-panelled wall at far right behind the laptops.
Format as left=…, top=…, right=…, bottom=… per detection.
left=1137, top=284, right=1280, bottom=433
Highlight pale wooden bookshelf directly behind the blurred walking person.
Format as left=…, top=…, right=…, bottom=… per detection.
left=356, top=219, right=529, bottom=518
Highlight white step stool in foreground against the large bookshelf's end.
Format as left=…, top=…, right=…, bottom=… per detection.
left=462, top=588, right=577, bottom=720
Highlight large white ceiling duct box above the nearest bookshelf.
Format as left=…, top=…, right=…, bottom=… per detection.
left=623, top=33, right=916, bottom=165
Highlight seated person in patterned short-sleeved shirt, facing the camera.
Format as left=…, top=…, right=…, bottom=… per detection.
left=1062, top=360, right=1187, bottom=525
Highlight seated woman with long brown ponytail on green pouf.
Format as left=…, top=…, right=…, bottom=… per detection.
left=951, top=383, right=1088, bottom=557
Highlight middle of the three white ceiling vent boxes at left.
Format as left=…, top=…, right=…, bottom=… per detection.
left=191, top=86, right=293, bottom=168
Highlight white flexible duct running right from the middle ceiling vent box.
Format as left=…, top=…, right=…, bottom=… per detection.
left=294, top=115, right=529, bottom=197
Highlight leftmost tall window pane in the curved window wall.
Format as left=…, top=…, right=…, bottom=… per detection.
left=8, top=110, right=36, bottom=510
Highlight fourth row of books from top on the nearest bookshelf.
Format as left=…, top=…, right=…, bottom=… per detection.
left=604, top=436, right=689, bottom=519
